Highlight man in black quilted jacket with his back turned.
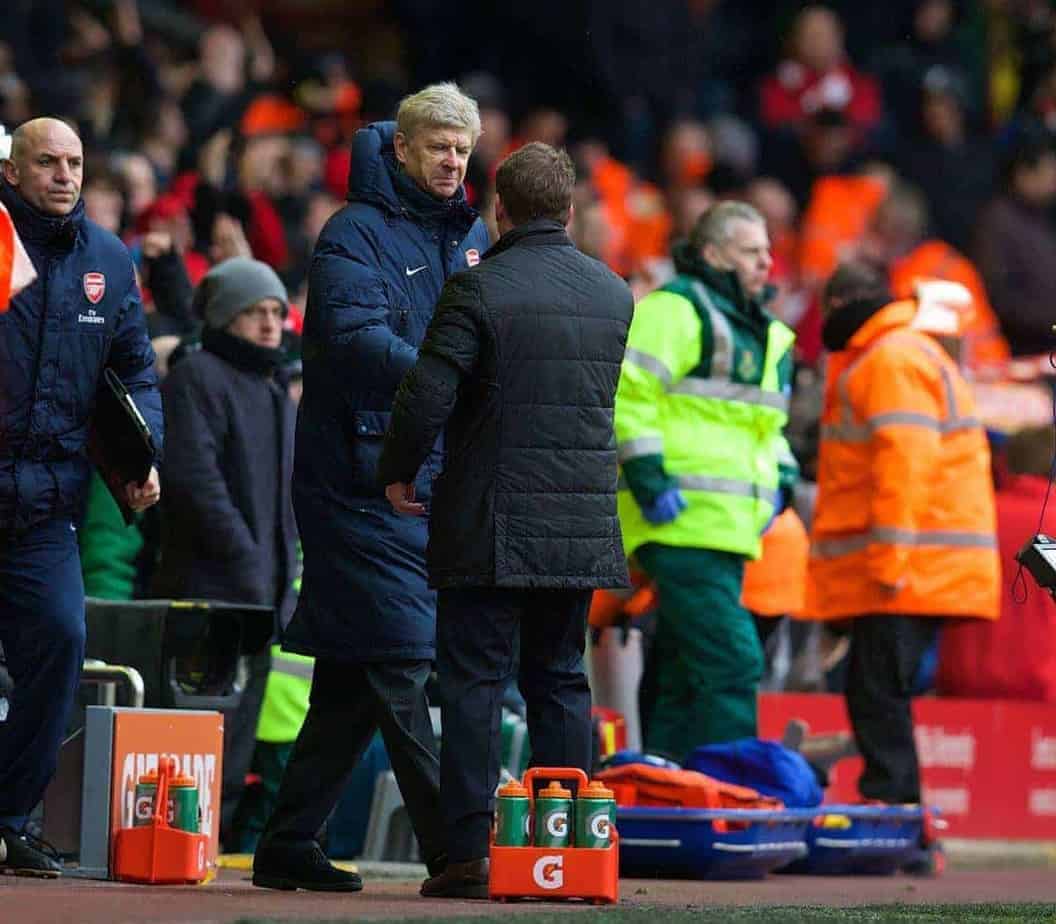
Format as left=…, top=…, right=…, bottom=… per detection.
left=379, top=143, right=634, bottom=898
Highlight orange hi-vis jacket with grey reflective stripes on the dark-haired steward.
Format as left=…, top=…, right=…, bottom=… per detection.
left=807, top=301, right=1000, bottom=619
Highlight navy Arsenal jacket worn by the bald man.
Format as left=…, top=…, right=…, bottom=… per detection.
left=0, top=181, right=164, bottom=531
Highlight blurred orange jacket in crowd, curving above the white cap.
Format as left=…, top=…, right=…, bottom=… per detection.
left=890, top=241, right=1012, bottom=372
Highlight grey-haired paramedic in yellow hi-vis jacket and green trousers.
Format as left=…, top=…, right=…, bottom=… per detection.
left=616, top=202, right=797, bottom=759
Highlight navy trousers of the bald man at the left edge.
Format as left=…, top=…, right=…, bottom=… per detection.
left=0, top=520, right=84, bottom=831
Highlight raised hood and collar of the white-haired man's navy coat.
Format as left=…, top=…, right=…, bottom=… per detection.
left=347, top=121, right=477, bottom=234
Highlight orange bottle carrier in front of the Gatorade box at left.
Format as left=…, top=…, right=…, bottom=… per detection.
left=113, top=757, right=209, bottom=885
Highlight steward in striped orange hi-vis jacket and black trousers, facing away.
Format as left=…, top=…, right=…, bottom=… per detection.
left=807, top=263, right=1000, bottom=803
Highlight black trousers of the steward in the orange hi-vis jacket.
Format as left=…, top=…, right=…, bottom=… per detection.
left=847, top=614, right=940, bottom=803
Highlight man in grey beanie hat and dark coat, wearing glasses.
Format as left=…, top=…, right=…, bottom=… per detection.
left=153, top=257, right=297, bottom=841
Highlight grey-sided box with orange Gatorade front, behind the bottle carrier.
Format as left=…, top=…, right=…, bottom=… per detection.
left=80, top=706, right=224, bottom=878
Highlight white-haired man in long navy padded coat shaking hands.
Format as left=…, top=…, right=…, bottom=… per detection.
left=253, top=83, right=489, bottom=891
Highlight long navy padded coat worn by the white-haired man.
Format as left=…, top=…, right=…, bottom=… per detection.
left=283, top=122, right=489, bottom=661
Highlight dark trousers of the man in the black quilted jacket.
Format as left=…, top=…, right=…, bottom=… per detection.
left=436, top=587, right=591, bottom=863
